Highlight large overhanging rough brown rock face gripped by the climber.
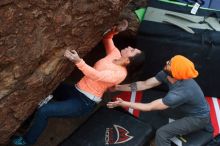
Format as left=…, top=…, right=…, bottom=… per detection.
left=0, top=0, right=129, bottom=144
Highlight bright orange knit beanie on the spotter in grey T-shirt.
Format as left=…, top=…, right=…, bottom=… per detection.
left=170, top=55, right=199, bottom=80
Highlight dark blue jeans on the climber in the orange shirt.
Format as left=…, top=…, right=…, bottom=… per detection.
left=24, top=84, right=96, bottom=144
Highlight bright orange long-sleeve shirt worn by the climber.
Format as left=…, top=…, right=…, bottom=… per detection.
left=76, top=32, right=127, bottom=98
